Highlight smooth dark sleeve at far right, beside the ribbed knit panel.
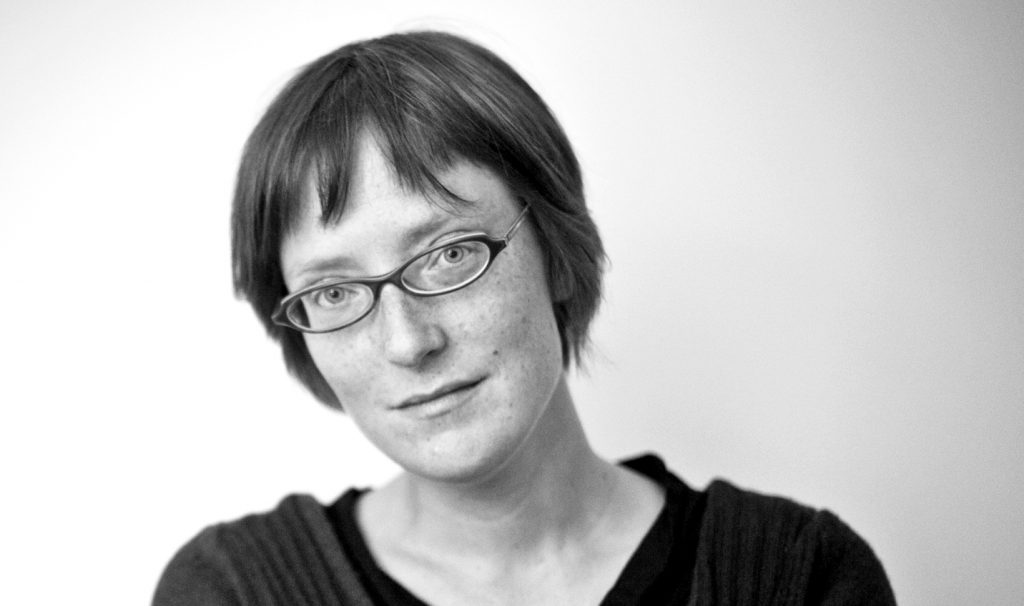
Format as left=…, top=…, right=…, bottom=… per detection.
left=806, top=511, right=896, bottom=606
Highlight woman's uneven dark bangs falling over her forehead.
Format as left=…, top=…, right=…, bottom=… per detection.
left=280, top=44, right=514, bottom=233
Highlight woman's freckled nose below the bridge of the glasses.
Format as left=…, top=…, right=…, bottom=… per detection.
left=377, top=285, right=447, bottom=367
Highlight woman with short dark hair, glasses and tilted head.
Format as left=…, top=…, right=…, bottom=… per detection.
left=154, top=33, right=893, bottom=606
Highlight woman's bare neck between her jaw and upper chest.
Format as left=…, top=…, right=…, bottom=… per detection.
left=372, top=378, right=617, bottom=561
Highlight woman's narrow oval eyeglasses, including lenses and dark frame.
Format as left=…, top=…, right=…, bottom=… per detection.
left=270, top=206, right=529, bottom=333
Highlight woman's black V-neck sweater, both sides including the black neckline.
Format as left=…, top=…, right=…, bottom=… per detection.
left=153, top=456, right=895, bottom=606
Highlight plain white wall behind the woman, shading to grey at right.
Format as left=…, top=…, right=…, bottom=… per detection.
left=0, top=0, right=1024, bottom=605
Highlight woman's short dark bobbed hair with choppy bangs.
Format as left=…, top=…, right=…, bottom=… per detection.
left=231, top=32, right=604, bottom=406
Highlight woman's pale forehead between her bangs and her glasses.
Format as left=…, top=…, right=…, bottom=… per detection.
left=281, top=136, right=517, bottom=288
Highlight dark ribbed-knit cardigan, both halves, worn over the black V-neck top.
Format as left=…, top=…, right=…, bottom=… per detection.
left=153, top=481, right=895, bottom=606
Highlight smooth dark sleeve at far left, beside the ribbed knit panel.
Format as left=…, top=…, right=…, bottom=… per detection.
left=153, top=527, right=243, bottom=606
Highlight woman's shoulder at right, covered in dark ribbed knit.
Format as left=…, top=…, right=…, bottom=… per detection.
left=696, top=480, right=895, bottom=605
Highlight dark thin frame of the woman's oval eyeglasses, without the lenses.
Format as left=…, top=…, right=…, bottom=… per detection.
left=270, top=205, right=529, bottom=335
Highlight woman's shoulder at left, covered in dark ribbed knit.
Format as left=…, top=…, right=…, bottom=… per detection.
left=153, top=494, right=330, bottom=606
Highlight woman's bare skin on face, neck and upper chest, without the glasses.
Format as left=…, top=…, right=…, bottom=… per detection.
left=281, top=135, right=664, bottom=604
